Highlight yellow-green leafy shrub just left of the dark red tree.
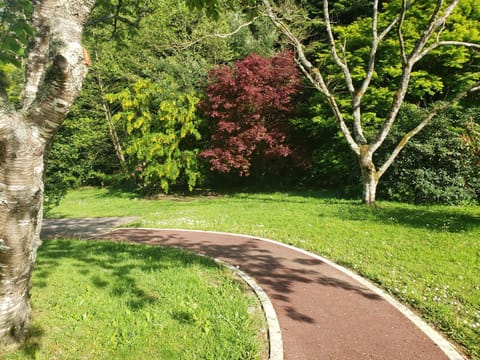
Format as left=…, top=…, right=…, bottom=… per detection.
left=107, top=80, right=200, bottom=192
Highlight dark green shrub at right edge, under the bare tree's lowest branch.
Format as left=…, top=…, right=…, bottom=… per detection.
left=379, top=107, right=480, bottom=204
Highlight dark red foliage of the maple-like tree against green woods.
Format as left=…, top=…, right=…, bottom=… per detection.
left=200, top=52, right=300, bottom=176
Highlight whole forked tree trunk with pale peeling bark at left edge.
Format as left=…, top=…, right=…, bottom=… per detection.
left=0, top=0, right=95, bottom=344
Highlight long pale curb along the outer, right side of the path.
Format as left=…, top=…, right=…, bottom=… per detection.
left=127, top=227, right=465, bottom=360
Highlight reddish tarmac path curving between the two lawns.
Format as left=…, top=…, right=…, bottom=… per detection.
left=42, top=219, right=462, bottom=360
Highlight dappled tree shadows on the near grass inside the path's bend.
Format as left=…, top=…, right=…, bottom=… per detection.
left=18, top=240, right=219, bottom=359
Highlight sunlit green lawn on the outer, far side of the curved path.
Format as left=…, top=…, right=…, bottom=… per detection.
left=46, top=188, right=480, bottom=360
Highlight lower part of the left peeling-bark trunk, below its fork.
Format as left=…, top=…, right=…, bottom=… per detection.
left=0, top=115, right=45, bottom=343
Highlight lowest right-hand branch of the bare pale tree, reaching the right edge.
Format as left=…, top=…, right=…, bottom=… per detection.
left=377, top=82, right=480, bottom=179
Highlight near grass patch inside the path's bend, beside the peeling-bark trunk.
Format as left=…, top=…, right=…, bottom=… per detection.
left=1, top=240, right=265, bottom=360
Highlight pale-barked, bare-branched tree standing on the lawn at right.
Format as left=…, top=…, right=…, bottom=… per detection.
left=262, top=0, right=480, bottom=205
